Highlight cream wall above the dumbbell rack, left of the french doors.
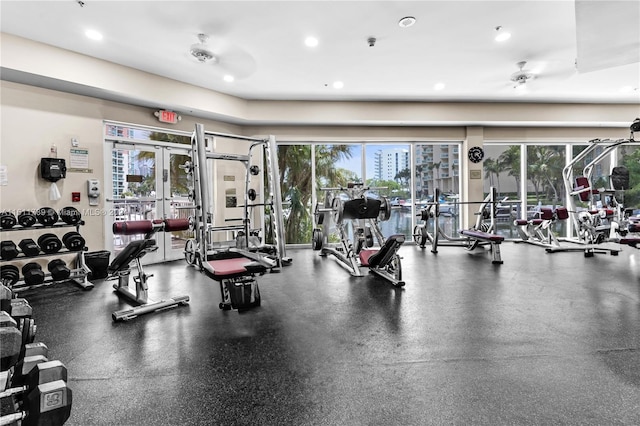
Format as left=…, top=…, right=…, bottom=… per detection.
left=0, top=81, right=241, bottom=251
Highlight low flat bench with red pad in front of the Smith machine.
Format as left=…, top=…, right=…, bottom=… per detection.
left=202, top=248, right=276, bottom=311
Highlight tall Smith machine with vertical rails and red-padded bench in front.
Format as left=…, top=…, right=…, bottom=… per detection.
left=183, top=124, right=282, bottom=310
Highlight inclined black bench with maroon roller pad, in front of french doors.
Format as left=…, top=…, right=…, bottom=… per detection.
left=107, top=219, right=189, bottom=321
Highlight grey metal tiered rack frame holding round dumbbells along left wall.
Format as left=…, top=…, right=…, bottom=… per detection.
left=0, top=220, right=93, bottom=292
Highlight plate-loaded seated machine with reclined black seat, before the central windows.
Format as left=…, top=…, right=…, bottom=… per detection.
left=312, top=183, right=405, bottom=287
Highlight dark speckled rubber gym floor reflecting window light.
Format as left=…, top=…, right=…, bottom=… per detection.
left=20, top=243, right=640, bottom=426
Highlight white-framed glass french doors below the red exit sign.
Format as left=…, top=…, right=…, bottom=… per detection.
left=105, top=140, right=193, bottom=264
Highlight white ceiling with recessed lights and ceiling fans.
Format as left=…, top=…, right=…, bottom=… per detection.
left=0, top=0, right=640, bottom=103
